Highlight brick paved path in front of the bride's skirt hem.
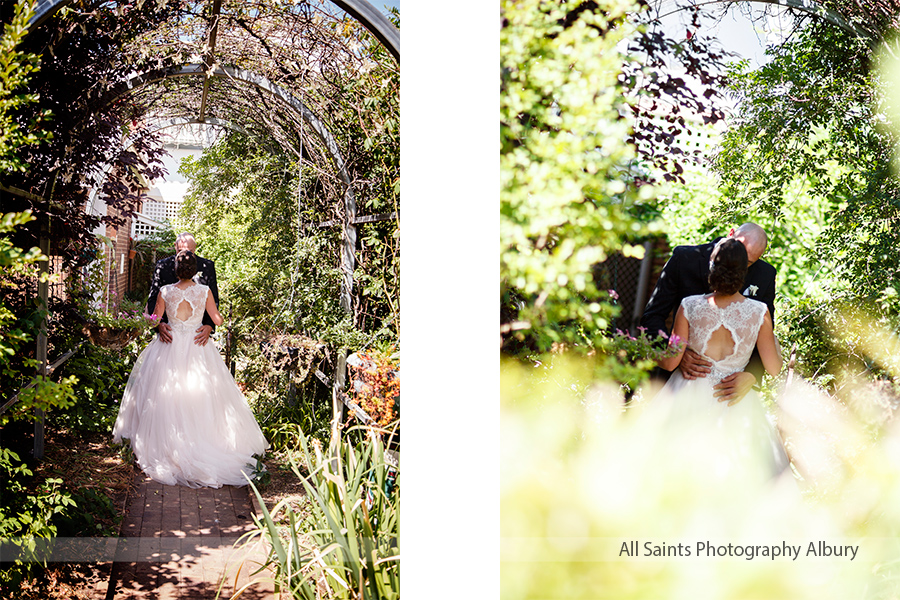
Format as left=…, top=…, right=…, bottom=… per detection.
left=106, top=472, right=276, bottom=600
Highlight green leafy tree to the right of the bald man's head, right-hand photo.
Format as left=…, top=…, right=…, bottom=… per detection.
left=716, top=21, right=888, bottom=300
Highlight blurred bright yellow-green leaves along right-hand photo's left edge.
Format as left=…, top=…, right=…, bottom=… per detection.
left=500, top=0, right=652, bottom=352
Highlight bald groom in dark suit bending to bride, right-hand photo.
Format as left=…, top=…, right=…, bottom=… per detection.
left=641, top=223, right=775, bottom=402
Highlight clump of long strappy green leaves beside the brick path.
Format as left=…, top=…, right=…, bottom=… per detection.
left=239, top=432, right=400, bottom=600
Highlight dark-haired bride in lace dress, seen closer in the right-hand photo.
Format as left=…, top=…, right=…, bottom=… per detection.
left=657, top=238, right=789, bottom=476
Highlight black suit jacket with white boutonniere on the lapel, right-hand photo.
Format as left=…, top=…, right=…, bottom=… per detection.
left=641, top=238, right=776, bottom=379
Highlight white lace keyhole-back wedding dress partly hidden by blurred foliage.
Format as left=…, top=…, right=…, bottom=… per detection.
left=657, top=294, right=789, bottom=477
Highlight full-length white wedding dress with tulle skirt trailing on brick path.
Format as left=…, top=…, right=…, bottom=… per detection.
left=113, top=283, right=269, bottom=488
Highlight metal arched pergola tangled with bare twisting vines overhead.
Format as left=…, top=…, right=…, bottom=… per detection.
left=12, top=0, right=400, bottom=454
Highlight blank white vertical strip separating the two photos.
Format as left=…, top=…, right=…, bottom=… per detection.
left=400, top=0, right=500, bottom=600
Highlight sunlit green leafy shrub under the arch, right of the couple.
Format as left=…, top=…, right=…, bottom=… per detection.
left=181, top=134, right=361, bottom=347
